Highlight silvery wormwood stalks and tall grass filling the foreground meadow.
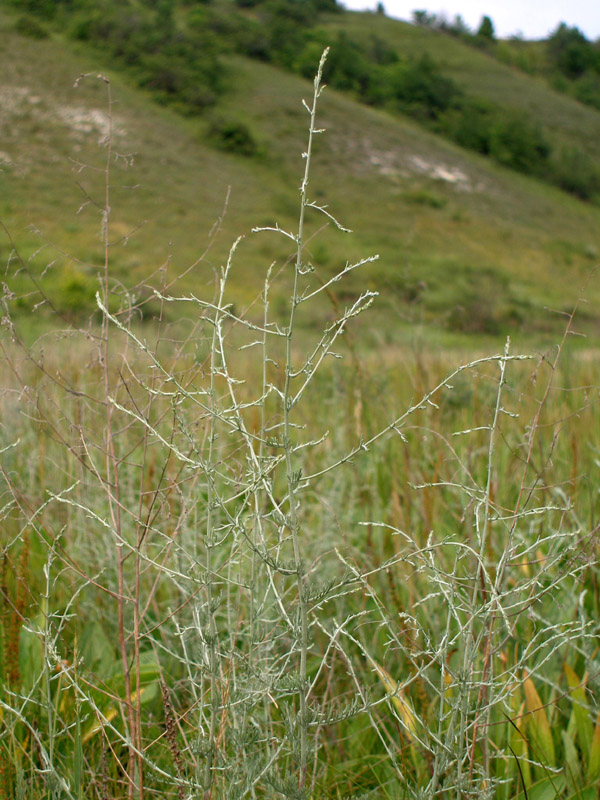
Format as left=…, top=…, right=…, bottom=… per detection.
left=0, top=51, right=600, bottom=800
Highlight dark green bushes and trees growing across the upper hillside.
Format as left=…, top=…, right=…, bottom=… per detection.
left=4, top=0, right=600, bottom=199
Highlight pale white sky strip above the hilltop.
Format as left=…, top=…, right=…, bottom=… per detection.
left=342, top=0, right=600, bottom=40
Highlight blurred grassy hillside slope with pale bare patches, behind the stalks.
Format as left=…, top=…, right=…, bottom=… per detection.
left=0, top=4, right=600, bottom=340
